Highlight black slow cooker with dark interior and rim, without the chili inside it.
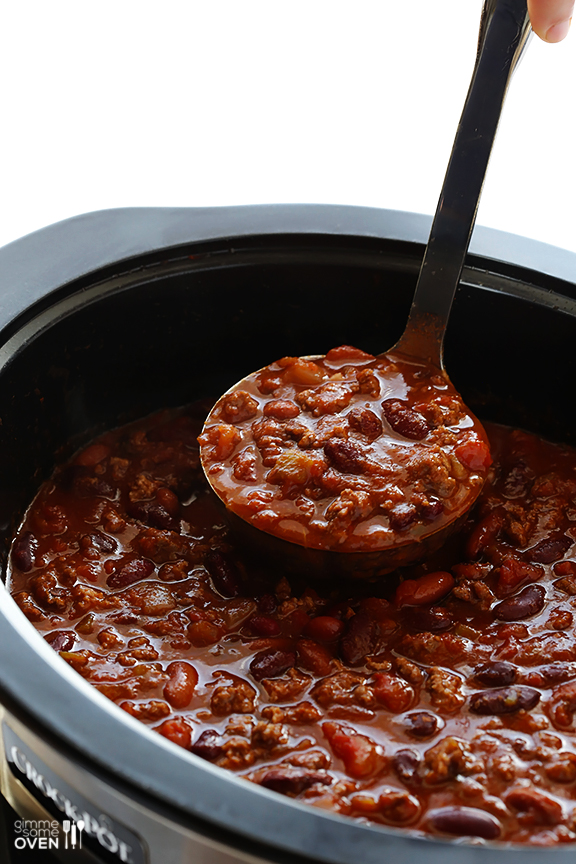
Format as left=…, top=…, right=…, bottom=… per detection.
left=0, top=205, right=576, bottom=864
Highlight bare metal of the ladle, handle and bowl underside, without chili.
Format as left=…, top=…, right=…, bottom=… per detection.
left=203, top=0, right=531, bottom=578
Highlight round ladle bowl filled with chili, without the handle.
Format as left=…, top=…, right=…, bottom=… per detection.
left=200, top=348, right=489, bottom=579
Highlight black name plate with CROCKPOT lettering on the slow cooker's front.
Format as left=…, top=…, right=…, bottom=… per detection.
left=2, top=724, right=145, bottom=864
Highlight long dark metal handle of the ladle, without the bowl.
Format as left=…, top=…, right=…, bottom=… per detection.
left=394, top=0, right=531, bottom=369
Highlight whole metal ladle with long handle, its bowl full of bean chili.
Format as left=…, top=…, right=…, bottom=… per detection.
left=199, top=0, right=530, bottom=578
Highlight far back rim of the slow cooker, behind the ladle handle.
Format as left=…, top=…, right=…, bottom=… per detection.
left=0, top=204, right=576, bottom=344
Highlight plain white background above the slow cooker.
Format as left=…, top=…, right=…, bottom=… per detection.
left=0, top=0, right=576, bottom=251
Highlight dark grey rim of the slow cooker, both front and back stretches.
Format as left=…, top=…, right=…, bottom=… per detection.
left=0, top=205, right=576, bottom=862
